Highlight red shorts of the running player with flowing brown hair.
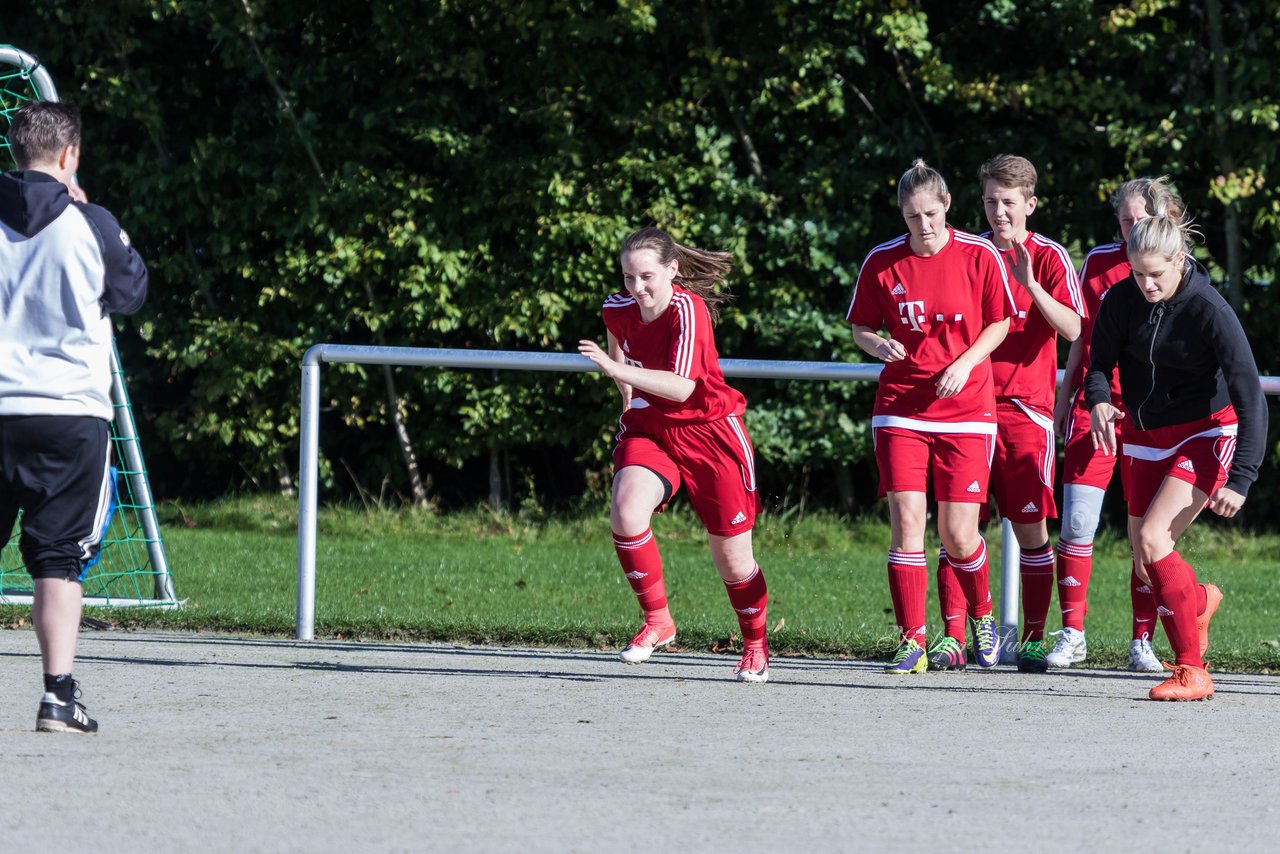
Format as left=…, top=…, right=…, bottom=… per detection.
left=613, top=415, right=760, bottom=536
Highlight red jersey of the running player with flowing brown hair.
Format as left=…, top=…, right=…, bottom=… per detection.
left=604, top=284, right=746, bottom=433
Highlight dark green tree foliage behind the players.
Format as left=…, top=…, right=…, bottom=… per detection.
left=4, top=0, right=1280, bottom=508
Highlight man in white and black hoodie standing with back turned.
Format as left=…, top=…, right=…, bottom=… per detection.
left=0, top=101, right=147, bottom=732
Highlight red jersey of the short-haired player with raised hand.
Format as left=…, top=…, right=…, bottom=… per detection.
left=983, top=232, right=1084, bottom=412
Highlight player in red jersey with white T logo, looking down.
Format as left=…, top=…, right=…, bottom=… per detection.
left=846, top=160, right=1014, bottom=673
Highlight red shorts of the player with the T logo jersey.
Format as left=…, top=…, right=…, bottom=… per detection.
left=872, top=421, right=996, bottom=504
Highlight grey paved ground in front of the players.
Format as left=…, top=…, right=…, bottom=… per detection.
left=0, top=630, right=1280, bottom=854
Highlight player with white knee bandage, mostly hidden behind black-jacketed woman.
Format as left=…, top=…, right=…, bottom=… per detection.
left=1046, top=178, right=1184, bottom=673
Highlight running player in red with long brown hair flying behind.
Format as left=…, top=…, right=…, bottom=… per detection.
left=577, top=228, right=769, bottom=682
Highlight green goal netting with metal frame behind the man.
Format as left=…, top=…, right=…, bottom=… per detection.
left=0, top=45, right=179, bottom=607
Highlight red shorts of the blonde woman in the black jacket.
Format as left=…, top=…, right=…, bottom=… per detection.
left=1124, top=406, right=1236, bottom=516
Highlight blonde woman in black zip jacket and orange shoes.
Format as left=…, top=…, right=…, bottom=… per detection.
left=1084, top=216, right=1267, bottom=700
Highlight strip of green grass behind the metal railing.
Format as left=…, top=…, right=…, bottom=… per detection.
left=0, top=498, right=1280, bottom=671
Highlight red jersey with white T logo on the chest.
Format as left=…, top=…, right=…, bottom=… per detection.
left=846, top=227, right=1014, bottom=433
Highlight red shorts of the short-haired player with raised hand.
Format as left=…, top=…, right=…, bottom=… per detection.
left=991, top=401, right=1057, bottom=525
